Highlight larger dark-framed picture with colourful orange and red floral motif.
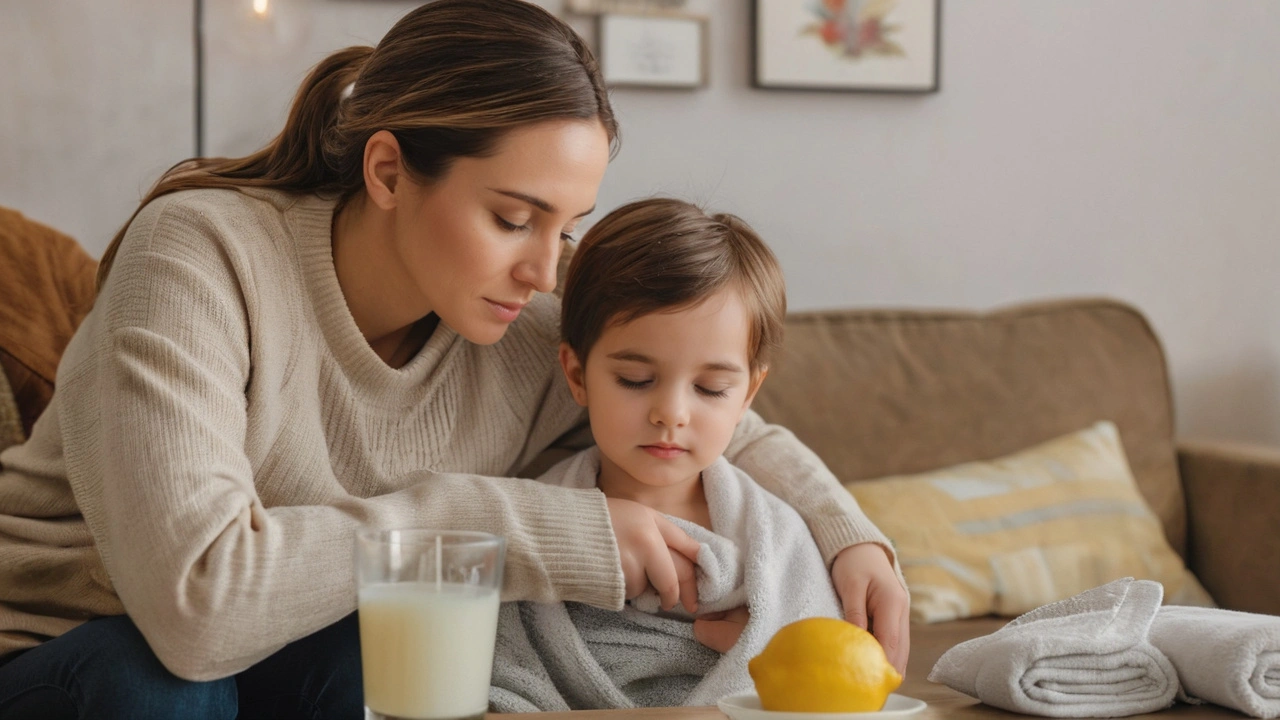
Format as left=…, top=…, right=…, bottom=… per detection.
left=753, top=0, right=942, bottom=92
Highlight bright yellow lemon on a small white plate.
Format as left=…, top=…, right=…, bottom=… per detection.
left=748, top=618, right=902, bottom=712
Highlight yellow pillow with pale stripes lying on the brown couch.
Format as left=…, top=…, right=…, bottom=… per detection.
left=845, top=421, right=1213, bottom=623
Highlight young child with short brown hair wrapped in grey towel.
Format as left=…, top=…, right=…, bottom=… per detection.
left=490, top=199, right=842, bottom=712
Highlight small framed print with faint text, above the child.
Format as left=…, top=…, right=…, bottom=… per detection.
left=598, top=13, right=707, bottom=87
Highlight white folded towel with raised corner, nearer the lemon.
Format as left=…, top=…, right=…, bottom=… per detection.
left=929, top=578, right=1178, bottom=717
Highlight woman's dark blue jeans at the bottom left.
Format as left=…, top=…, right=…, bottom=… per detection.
left=0, top=614, right=365, bottom=720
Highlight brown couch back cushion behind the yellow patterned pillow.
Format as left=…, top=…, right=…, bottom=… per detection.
left=754, top=300, right=1187, bottom=553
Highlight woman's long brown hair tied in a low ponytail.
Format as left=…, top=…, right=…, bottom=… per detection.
left=97, top=0, right=618, bottom=288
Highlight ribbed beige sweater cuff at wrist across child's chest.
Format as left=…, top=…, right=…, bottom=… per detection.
left=517, top=488, right=626, bottom=610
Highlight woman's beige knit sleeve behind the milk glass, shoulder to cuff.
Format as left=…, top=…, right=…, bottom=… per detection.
left=68, top=194, right=625, bottom=680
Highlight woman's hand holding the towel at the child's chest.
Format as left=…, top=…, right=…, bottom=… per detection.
left=605, top=497, right=700, bottom=612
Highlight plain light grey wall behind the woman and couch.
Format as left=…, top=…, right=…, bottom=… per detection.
left=0, top=0, right=1280, bottom=445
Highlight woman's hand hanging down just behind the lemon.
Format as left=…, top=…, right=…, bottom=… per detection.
left=831, top=542, right=911, bottom=673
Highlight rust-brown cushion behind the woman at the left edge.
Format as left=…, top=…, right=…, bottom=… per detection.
left=0, top=208, right=97, bottom=436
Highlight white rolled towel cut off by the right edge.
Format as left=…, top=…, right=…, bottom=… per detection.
left=1151, top=607, right=1280, bottom=717
